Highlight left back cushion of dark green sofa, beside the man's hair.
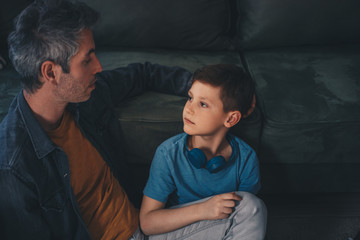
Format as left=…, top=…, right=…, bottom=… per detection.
left=85, top=0, right=235, bottom=49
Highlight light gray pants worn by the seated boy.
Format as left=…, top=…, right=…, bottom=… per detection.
left=129, top=192, right=267, bottom=240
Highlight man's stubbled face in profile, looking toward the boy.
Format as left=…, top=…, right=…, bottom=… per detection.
left=54, top=29, right=102, bottom=103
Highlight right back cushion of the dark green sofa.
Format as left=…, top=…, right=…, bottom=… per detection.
left=238, top=0, right=360, bottom=49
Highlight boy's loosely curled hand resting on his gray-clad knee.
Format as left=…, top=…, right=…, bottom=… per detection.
left=201, top=192, right=242, bottom=220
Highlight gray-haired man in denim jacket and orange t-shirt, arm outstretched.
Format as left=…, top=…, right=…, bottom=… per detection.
left=0, top=0, right=191, bottom=239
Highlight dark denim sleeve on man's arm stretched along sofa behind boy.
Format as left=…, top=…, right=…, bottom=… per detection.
left=98, top=62, right=192, bottom=106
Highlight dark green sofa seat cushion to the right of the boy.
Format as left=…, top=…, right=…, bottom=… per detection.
left=245, top=45, right=360, bottom=191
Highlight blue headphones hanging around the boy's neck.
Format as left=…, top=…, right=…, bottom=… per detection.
left=188, top=148, right=226, bottom=173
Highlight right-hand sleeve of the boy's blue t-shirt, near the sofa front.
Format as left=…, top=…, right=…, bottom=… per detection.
left=238, top=149, right=261, bottom=194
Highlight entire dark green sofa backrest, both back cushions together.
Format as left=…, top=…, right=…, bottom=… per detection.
left=84, top=0, right=360, bottom=50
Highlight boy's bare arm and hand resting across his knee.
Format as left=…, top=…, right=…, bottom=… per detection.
left=140, top=193, right=241, bottom=235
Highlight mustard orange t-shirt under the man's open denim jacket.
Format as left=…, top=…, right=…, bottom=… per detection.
left=47, top=111, right=139, bottom=240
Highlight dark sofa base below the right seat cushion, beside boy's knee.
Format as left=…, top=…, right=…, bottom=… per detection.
left=263, top=193, right=360, bottom=240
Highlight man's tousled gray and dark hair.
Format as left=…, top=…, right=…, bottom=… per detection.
left=8, top=0, right=99, bottom=92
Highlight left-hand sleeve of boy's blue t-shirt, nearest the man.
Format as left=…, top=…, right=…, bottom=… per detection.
left=144, top=145, right=176, bottom=203
